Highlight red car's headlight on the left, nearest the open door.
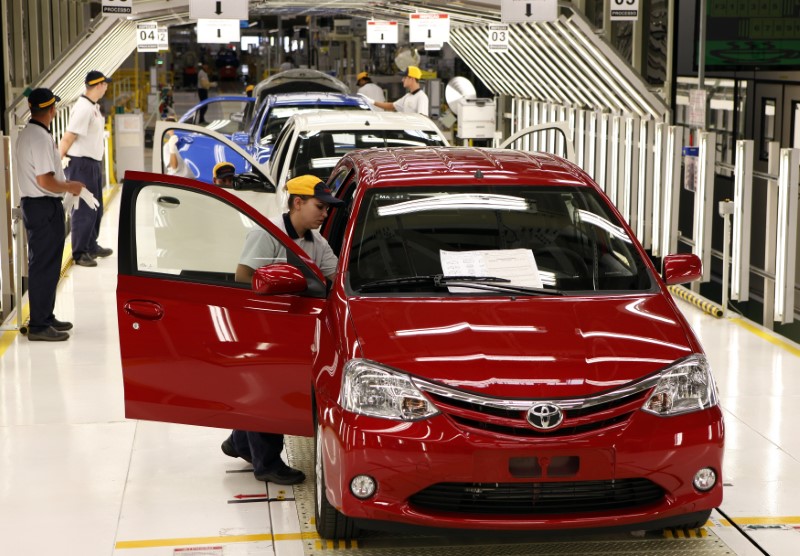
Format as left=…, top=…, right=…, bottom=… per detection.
left=340, top=359, right=439, bottom=421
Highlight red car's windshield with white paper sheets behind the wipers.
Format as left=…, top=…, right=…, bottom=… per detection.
left=348, top=186, right=655, bottom=295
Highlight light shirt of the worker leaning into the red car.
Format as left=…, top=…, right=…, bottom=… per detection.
left=239, top=213, right=339, bottom=276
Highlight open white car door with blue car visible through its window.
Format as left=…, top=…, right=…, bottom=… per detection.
left=152, top=121, right=288, bottom=217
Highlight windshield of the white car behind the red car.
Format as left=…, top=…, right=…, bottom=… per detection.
left=289, top=129, right=444, bottom=180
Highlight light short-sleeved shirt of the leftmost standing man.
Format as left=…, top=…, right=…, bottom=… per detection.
left=14, top=120, right=66, bottom=199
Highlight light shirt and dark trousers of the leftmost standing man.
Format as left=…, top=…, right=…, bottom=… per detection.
left=14, top=120, right=66, bottom=333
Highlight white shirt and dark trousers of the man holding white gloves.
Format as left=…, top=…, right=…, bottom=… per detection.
left=65, top=95, right=105, bottom=261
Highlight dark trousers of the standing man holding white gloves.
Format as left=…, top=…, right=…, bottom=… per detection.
left=64, top=156, right=103, bottom=260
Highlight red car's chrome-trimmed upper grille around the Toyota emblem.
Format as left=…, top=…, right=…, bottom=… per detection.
left=417, top=379, right=654, bottom=438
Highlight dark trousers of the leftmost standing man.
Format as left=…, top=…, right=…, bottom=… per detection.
left=21, top=197, right=65, bottom=332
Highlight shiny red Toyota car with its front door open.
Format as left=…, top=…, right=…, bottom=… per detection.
left=117, top=147, right=724, bottom=538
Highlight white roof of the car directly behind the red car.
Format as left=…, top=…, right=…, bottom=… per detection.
left=286, top=110, right=439, bottom=131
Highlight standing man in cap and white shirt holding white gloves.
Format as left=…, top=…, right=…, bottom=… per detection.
left=58, top=70, right=114, bottom=266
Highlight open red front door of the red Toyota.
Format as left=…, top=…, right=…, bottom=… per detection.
left=117, top=172, right=326, bottom=435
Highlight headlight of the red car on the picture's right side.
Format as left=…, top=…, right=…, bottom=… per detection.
left=642, top=355, right=718, bottom=416
